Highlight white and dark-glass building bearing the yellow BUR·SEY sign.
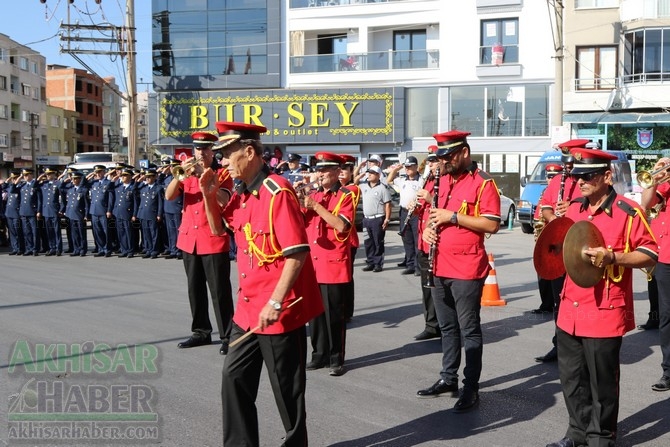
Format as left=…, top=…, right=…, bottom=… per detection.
left=150, top=0, right=555, bottom=196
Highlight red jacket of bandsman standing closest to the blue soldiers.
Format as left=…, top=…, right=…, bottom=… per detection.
left=177, top=169, right=233, bottom=255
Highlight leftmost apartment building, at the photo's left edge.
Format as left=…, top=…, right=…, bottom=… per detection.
left=0, top=34, right=47, bottom=177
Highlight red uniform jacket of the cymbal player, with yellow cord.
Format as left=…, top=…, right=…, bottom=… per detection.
left=556, top=188, right=658, bottom=338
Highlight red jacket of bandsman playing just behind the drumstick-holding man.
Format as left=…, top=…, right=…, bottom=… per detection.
left=305, top=182, right=356, bottom=284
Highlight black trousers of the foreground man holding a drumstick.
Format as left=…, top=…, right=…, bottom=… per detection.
left=226, top=324, right=308, bottom=447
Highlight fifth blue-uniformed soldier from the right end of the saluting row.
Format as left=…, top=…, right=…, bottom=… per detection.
left=62, top=172, right=89, bottom=256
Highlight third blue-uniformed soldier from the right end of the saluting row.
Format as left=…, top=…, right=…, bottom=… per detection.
left=112, top=169, right=135, bottom=258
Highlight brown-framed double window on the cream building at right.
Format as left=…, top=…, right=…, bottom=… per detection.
left=575, top=47, right=617, bottom=90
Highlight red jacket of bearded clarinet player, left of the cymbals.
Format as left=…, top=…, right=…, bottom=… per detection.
left=435, top=164, right=500, bottom=279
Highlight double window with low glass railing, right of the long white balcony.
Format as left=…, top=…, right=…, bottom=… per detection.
left=479, top=18, right=519, bottom=65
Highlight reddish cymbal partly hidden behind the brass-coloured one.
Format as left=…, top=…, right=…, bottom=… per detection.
left=533, top=217, right=575, bottom=280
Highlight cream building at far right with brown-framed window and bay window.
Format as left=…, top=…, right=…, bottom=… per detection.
left=563, top=0, right=670, bottom=172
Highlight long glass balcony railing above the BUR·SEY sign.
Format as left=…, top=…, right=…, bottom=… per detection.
left=291, top=50, right=440, bottom=73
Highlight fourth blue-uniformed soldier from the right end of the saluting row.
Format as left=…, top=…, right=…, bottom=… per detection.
left=89, top=165, right=114, bottom=258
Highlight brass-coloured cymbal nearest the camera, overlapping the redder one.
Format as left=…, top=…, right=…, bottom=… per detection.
left=563, top=220, right=605, bottom=288
